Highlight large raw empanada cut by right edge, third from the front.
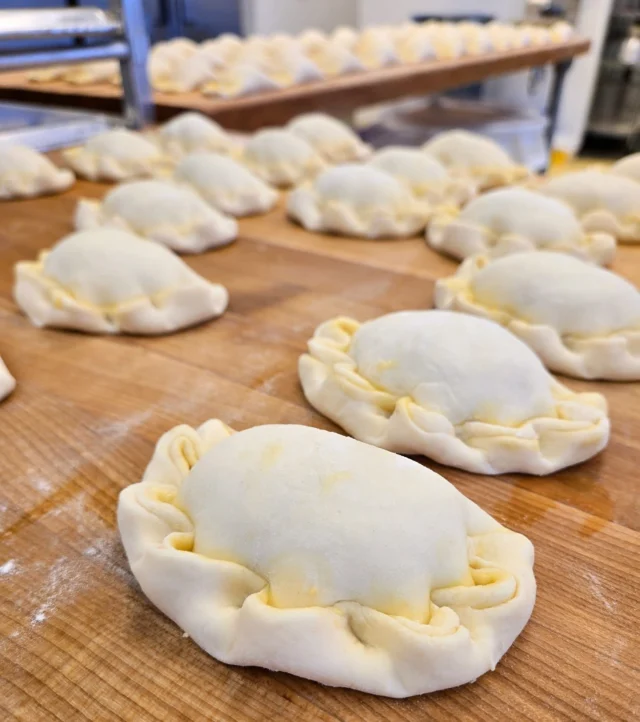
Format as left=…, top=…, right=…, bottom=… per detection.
left=436, top=252, right=640, bottom=381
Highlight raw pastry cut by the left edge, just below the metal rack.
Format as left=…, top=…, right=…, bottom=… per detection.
left=0, top=143, right=76, bottom=201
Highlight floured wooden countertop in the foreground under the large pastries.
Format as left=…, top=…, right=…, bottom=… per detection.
left=0, top=177, right=640, bottom=722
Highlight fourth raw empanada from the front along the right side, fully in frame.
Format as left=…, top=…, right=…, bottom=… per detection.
left=426, top=188, right=616, bottom=264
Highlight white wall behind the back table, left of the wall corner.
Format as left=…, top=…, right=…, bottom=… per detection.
left=241, top=0, right=366, bottom=35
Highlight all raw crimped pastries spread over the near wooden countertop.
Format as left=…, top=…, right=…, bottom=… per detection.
left=0, top=107, right=640, bottom=697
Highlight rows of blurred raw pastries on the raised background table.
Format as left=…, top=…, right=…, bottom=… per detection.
left=27, top=21, right=573, bottom=97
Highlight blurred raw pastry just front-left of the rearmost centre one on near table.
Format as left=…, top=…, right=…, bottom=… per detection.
left=242, top=128, right=326, bottom=188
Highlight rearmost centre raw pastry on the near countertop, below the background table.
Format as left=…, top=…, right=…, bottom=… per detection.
left=287, top=113, right=371, bottom=163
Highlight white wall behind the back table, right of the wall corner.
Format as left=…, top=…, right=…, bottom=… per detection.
left=356, top=0, right=526, bottom=26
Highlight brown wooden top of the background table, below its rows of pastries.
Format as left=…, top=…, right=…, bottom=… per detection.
left=0, top=38, right=589, bottom=130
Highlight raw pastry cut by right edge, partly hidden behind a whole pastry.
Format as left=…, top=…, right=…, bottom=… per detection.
left=539, top=170, right=640, bottom=243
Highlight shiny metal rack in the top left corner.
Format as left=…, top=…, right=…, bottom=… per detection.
left=0, top=0, right=153, bottom=150
